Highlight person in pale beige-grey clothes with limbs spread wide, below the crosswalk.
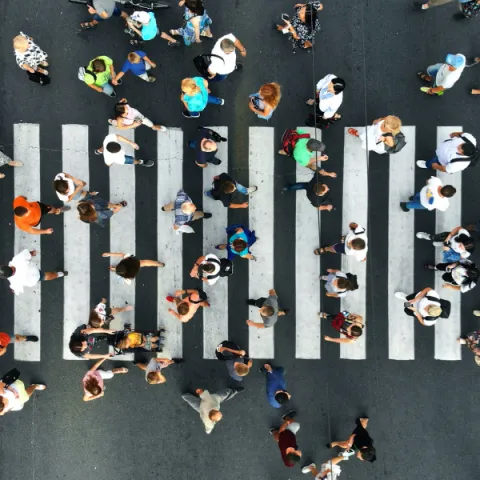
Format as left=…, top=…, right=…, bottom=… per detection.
left=182, top=387, right=244, bottom=434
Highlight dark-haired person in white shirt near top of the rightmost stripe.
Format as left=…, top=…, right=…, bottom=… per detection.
left=417, top=132, right=477, bottom=173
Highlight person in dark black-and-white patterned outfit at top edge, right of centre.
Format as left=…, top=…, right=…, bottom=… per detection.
left=274, top=0, right=323, bottom=53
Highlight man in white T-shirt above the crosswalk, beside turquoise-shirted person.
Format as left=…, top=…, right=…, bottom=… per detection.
left=208, top=33, right=247, bottom=82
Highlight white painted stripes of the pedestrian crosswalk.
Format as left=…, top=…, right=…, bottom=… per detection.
left=5, top=124, right=461, bottom=361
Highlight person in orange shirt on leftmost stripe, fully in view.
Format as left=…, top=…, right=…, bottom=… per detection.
left=13, top=196, right=70, bottom=235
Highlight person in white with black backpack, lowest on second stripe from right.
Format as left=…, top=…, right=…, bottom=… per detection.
left=395, top=287, right=451, bottom=327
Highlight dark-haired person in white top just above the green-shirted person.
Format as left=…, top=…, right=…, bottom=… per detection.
left=305, top=73, right=345, bottom=130
